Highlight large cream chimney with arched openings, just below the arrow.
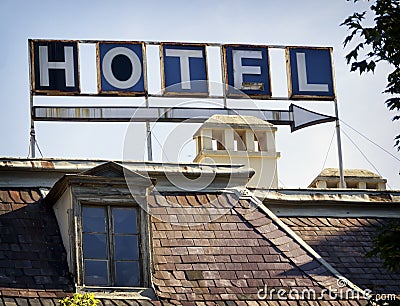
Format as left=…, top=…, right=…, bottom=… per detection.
left=193, top=115, right=280, bottom=188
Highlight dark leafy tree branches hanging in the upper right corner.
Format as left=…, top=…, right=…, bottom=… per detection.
left=341, top=0, right=400, bottom=151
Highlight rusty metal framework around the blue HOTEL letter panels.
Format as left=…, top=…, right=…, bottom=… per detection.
left=28, top=39, right=336, bottom=101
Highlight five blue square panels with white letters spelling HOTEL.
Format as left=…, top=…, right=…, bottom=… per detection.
left=29, top=40, right=335, bottom=100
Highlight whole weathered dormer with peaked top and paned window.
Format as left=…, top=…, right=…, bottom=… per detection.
left=46, top=163, right=154, bottom=298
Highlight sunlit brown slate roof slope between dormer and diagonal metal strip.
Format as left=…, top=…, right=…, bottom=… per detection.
left=152, top=194, right=346, bottom=301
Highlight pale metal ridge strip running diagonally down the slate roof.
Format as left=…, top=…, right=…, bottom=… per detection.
left=232, top=188, right=367, bottom=296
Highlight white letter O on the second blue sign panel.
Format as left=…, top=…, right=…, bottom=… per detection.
left=103, top=47, right=142, bottom=89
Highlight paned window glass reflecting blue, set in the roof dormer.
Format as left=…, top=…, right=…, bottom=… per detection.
left=82, top=206, right=142, bottom=287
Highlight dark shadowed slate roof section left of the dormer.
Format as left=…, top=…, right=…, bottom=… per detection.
left=0, top=188, right=72, bottom=296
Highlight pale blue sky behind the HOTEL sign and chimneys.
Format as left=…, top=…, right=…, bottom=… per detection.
left=0, top=0, right=400, bottom=189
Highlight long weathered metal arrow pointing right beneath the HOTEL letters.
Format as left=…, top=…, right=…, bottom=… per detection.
left=32, top=104, right=336, bottom=132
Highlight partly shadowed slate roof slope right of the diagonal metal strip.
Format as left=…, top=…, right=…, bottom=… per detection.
left=281, top=217, right=400, bottom=294
